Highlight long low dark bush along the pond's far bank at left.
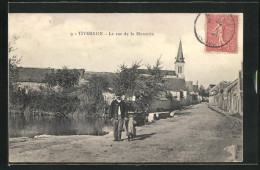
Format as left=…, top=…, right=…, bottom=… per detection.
left=10, top=88, right=80, bottom=115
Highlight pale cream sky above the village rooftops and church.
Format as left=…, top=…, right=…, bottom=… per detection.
left=8, top=13, right=243, bottom=87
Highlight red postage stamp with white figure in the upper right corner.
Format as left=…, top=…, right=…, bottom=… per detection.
left=206, top=14, right=238, bottom=53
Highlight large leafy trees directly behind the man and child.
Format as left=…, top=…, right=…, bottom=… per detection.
left=113, top=59, right=164, bottom=113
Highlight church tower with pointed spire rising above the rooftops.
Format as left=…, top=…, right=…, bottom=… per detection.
left=175, top=41, right=185, bottom=79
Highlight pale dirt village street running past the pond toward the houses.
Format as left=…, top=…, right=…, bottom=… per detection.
left=9, top=103, right=243, bottom=163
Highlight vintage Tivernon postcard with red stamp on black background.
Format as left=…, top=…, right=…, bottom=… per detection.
left=8, top=13, right=243, bottom=163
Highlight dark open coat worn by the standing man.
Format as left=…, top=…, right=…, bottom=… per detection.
left=110, top=100, right=128, bottom=119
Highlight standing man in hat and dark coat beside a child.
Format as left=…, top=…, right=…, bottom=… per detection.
left=110, top=95, right=128, bottom=141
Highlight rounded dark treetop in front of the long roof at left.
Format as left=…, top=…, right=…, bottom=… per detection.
left=44, top=67, right=80, bottom=89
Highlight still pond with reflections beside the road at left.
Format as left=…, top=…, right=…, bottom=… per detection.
left=8, top=114, right=113, bottom=138
